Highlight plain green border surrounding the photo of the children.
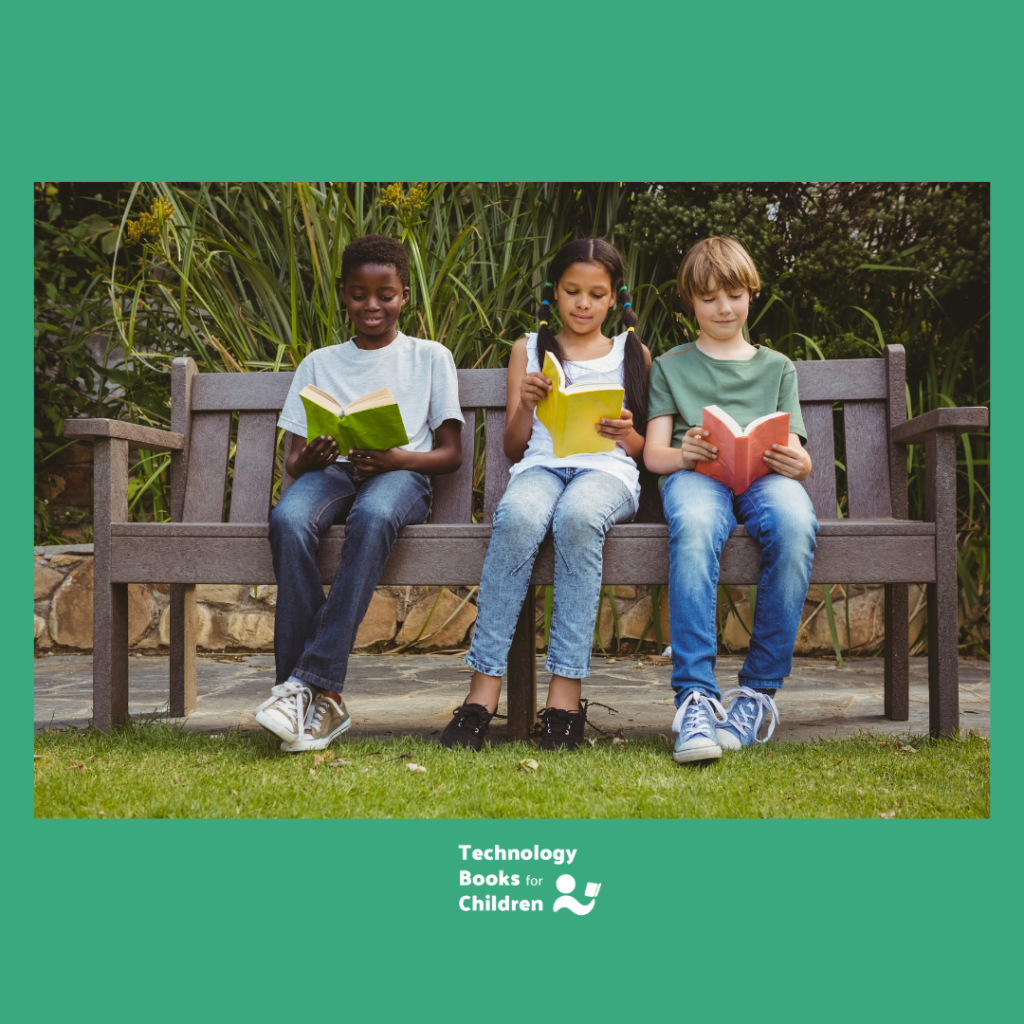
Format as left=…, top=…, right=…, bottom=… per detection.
left=6, top=2, right=1024, bottom=1020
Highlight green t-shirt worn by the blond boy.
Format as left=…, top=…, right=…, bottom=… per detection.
left=647, top=342, right=807, bottom=486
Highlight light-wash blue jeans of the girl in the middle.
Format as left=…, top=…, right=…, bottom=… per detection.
left=466, top=466, right=633, bottom=679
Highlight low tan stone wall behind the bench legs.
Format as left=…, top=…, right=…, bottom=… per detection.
left=35, top=544, right=925, bottom=654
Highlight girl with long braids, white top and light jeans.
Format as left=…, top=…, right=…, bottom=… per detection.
left=441, top=239, right=650, bottom=751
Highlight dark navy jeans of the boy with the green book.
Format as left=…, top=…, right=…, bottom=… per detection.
left=270, top=463, right=430, bottom=693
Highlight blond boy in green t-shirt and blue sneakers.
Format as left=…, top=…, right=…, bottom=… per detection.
left=644, top=238, right=818, bottom=762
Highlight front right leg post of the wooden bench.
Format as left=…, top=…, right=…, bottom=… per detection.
left=925, top=430, right=959, bottom=736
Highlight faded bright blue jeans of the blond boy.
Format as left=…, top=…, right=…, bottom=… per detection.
left=662, top=470, right=818, bottom=708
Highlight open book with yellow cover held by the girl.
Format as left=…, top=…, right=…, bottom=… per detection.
left=537, top=352, right=626, bottom=459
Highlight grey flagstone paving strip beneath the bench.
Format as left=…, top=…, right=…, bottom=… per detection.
left=35, top=654, right=989, bottom=742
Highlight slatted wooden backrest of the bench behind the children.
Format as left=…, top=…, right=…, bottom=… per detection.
left=171, top=345, right=907, bottom=523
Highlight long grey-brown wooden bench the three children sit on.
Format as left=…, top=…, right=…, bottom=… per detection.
left=65, top=345, right=988, bottom=738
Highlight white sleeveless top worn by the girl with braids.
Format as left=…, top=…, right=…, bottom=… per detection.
left=509, top=334, right=640, bottom=515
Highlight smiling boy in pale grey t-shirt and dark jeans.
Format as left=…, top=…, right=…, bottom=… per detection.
left=256, top=234, right=464, bottom=752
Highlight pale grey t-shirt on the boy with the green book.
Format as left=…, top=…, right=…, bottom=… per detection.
left=278, top=334, right=465, bottom=461
